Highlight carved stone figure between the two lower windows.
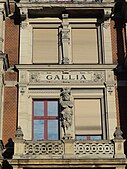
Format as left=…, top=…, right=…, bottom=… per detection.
left=60, top=88, right=73, bottom=139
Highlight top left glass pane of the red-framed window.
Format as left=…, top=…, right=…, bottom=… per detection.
left=34, top=101, right=44, bottom=116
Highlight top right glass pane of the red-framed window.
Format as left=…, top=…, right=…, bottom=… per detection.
left=48, top=101, right=58, bottom=116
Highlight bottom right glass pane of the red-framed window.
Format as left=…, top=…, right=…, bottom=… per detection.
left=48, top=120, right=58, bottom=140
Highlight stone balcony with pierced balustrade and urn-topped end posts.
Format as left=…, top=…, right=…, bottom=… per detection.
left=13, top=128, right=125, bottom=160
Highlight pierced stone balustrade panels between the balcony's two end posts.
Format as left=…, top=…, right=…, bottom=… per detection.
left=23, top=140, right=115, bottom=158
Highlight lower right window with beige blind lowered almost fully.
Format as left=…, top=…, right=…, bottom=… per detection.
left=75, top=99, right=102, bottom=140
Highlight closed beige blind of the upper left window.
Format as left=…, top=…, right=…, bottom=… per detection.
left=33, top=29, right=58, bottom=63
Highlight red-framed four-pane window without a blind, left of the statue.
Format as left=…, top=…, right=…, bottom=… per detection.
left=33, top=100, right=59, bottom=140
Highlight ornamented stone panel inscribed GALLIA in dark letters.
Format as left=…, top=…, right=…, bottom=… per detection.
left=30, top=71, right=104, bottom=82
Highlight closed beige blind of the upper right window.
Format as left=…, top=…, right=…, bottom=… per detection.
left=72, top=29, right=98, bottom=64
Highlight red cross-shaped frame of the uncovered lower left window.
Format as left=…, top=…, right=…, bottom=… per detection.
left=32, top=99, right=59, bottom=140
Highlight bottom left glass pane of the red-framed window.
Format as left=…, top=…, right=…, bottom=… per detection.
left=33, top=120, right=44, bottom=140
